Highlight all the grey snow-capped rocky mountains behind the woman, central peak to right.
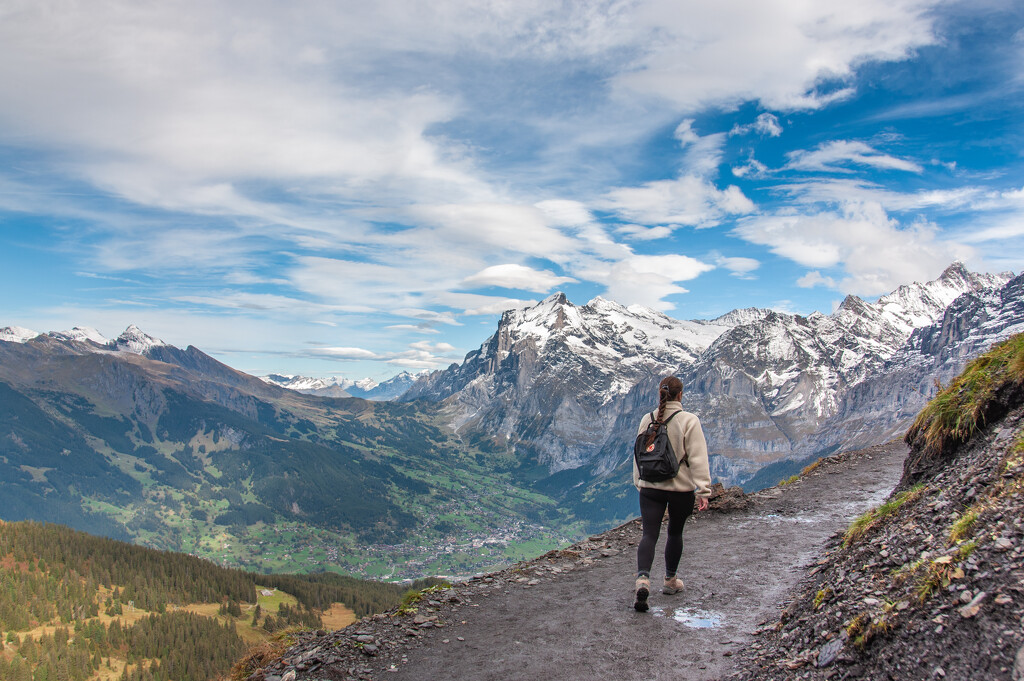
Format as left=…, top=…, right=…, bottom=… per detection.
left=406, top=263, right=1011, bottom=481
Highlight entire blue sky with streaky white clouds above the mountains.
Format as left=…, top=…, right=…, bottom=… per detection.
left=0, top=0, right=1024, bottom=379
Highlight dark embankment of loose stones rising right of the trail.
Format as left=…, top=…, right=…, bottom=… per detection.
left=730, top=356, right=1024, bottom=681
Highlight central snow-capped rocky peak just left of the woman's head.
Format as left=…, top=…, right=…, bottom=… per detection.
left=402, top=294, right=770, bottom=473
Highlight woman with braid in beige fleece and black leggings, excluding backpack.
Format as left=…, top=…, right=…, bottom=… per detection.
left=633, top=376, right=711, bottom=612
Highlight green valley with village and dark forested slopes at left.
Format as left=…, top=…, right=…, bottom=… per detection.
left=0, top=338, right=585, bottom=580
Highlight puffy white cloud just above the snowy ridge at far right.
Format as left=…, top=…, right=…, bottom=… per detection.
left=733, top=204, right=974, bottom=296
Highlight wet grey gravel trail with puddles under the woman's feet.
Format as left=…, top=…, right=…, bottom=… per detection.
left=382, top=442, right=906, bottom=681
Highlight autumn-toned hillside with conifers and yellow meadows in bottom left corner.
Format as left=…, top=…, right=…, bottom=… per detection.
left=0, top=522, right=438, bottom=681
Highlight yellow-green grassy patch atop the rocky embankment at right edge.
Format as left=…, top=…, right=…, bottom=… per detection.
left=906, top=334, right=1024, bottom=455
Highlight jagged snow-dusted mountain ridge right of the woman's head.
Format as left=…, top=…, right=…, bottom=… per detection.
left=599, top=263, right=1024, bottom=480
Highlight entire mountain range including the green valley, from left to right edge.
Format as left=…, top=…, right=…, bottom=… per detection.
left=0, top=263, right=1024, bottom=576
